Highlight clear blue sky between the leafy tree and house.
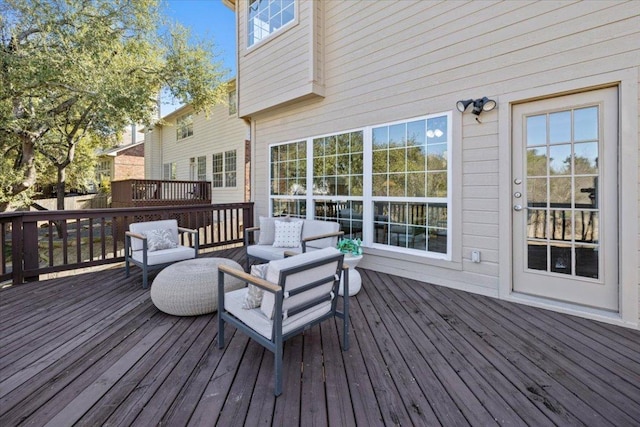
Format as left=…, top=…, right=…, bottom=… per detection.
left=162, top=0, right=236, bottom=116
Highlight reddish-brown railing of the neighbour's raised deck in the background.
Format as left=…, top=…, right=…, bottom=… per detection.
left=111, top=179, right=211, bottom=208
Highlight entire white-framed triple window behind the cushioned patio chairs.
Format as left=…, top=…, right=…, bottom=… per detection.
left=270, top=113, right=451, bottom=257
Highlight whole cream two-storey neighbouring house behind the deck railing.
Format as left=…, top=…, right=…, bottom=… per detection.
left=145, top=81, right=249, bottom=203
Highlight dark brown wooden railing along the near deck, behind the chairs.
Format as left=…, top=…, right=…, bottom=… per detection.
left=0, top=203, right=253, bottom=285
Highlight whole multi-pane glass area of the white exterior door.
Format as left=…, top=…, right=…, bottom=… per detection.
left=524, top=106, right=600, bottom=278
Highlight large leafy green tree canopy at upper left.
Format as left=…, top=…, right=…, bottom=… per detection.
left=0, top=0, right=226, bottom=211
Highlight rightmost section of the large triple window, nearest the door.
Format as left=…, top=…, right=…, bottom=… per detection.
left=372, top=116, right=449, bottom=253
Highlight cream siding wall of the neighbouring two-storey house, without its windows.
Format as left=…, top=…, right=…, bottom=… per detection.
left=145, top=85, right=248, bottom=203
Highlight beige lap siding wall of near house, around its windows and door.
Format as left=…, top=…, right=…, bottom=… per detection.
left=236, top=1, right=640, bottom=327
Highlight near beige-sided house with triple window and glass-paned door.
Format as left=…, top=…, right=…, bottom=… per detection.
left=224, top=0, right=640, bottom=327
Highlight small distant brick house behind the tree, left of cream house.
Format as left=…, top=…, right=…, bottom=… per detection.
left=96, top=140, right=145, bottom=184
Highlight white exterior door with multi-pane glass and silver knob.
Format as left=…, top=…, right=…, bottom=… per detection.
left=511, top=88, right=619, bottom=311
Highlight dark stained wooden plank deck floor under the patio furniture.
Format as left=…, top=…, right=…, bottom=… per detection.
left=0, top=249, right=640, bottom=426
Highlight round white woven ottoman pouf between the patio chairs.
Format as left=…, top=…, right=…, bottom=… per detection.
left=150, top=258, right=245, bottom=316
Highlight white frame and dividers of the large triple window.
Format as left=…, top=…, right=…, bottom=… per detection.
left=267, top=111, right=452, bottom=261
